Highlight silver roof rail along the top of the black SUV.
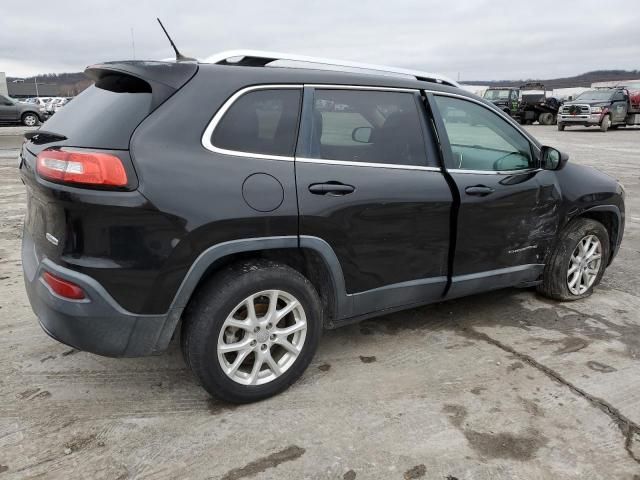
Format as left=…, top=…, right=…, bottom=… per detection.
left=203, top=50, right=460, bottom=87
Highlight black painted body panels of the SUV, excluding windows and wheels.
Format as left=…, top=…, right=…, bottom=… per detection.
left=21, top=62, right=624, bottom=355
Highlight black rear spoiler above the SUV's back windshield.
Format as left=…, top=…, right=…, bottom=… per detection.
left=84, top=61, right=198, bottom=110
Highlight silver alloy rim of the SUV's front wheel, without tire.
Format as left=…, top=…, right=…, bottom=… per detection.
left=567, top=235, right=602, bottom=295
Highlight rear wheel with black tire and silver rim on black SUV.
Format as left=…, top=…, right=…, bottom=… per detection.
left=181, top=260, right=322, bottom=403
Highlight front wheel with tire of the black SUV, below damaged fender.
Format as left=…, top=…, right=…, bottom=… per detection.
left=538, top=218, right=610, bottom=302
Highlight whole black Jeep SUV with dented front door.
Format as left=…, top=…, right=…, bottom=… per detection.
left=20, top=53, right=624, bottom=402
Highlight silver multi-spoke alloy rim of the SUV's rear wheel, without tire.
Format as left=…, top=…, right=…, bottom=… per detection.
left=217, top=290, right=307, bottom=385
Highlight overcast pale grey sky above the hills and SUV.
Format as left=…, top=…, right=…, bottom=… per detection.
left=0, top=0, right=640, bottom=81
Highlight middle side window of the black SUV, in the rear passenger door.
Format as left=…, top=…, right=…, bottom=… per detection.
left=311, top=90, right=426, bottom=166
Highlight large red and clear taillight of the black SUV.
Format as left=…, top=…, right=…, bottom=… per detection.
left=37, top=150, right=127, bottom=187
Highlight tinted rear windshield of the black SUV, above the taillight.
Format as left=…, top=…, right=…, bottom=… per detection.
left=43, top=75, right=151, bottom=150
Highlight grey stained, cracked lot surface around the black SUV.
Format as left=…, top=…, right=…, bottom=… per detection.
left=0, top=125, right=640, bottom=480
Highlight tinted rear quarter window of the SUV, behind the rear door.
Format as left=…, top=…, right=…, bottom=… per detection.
left=211, top=88, right=301, bottom=157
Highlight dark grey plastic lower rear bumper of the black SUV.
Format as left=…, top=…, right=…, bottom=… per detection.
left=22, top=229, right=183, bottom=357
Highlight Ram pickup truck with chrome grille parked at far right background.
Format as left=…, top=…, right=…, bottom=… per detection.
left=558, top=87, right=640, bottom=132
